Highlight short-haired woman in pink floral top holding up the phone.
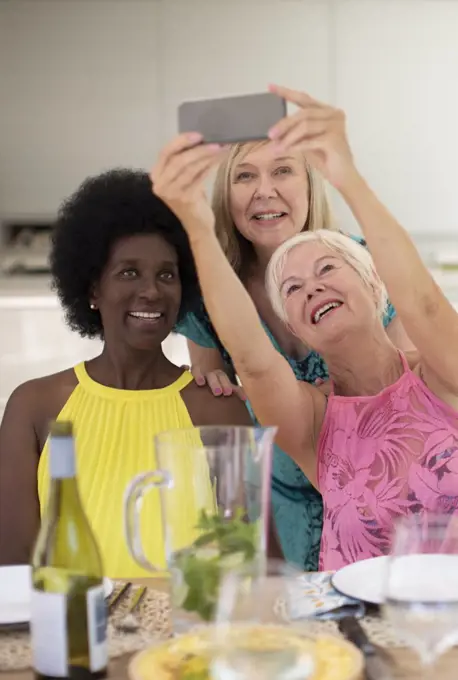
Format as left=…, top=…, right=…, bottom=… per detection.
left=153, top=87, right=458, bottom=569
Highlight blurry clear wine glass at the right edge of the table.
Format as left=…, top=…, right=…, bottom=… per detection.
left=384, top=513, right=458, bottom=674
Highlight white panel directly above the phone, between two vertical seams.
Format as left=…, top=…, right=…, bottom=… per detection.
left=160, top=0, right=332, bottom=137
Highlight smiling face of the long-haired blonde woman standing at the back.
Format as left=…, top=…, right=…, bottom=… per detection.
left=229, top=144, right=309, bottom=252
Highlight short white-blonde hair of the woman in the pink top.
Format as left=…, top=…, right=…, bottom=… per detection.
left=266, top=229, right=388, bottom=322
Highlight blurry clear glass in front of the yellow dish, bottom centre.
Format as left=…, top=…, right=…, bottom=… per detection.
left=211, top=560, right=315, bottom=680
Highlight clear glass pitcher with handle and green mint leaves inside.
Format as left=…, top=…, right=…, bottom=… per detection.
left=124, top=426, right=277, bottom=633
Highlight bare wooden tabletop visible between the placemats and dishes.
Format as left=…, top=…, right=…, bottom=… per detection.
left=0, top=578, right=458, bottom=680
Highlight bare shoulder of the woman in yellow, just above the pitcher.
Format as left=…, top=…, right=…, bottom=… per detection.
left=181, top=380, right=252, bottom=425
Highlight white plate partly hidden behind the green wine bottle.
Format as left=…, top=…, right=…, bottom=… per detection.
left=0, top=565, right=113, bottom=625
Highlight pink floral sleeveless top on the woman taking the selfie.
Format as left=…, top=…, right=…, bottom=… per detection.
left=318, top=355, right=458, bottom=570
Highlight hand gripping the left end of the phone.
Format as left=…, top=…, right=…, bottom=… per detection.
left=150, top=132, right=224, bottom=237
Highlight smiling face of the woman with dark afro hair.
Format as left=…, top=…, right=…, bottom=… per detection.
left=91, top=234, right=181, bottom=350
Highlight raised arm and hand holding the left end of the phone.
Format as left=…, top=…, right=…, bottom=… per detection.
left=152, top=135, right=322, bottom=473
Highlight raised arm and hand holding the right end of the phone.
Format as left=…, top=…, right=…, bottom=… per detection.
left=270, top=86, right=458, bottom=396
